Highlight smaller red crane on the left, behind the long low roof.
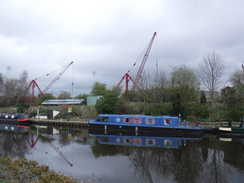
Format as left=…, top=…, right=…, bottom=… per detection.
left=27, top=61, right=73, bottom=99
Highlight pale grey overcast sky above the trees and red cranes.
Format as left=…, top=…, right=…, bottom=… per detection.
left=0, top=0, right=244, bottom=96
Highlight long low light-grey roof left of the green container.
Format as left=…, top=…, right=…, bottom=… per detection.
left=41, top=99, right=84, bottom=105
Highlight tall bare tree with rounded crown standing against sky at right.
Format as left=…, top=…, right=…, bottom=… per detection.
left=199, top=52, right=225, bottom=102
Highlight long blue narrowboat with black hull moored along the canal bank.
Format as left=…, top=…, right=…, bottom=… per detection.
left=88, top=114, right=205, bottom=134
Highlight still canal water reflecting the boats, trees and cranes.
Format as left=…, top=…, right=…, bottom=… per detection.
left=0, top=124, right=244, bottom=183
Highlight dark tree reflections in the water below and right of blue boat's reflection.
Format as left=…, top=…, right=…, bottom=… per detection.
left=92, top=136, right=244, bottom=183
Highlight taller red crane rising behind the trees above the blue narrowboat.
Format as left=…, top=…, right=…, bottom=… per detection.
left=115, top=32, right=157, bottom=90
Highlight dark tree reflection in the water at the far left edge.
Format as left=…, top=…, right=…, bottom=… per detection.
left=0, top=131, right=28, bottom=158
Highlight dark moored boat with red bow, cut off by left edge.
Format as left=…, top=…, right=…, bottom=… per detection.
left=0, top=113, right=30, bottom=124
